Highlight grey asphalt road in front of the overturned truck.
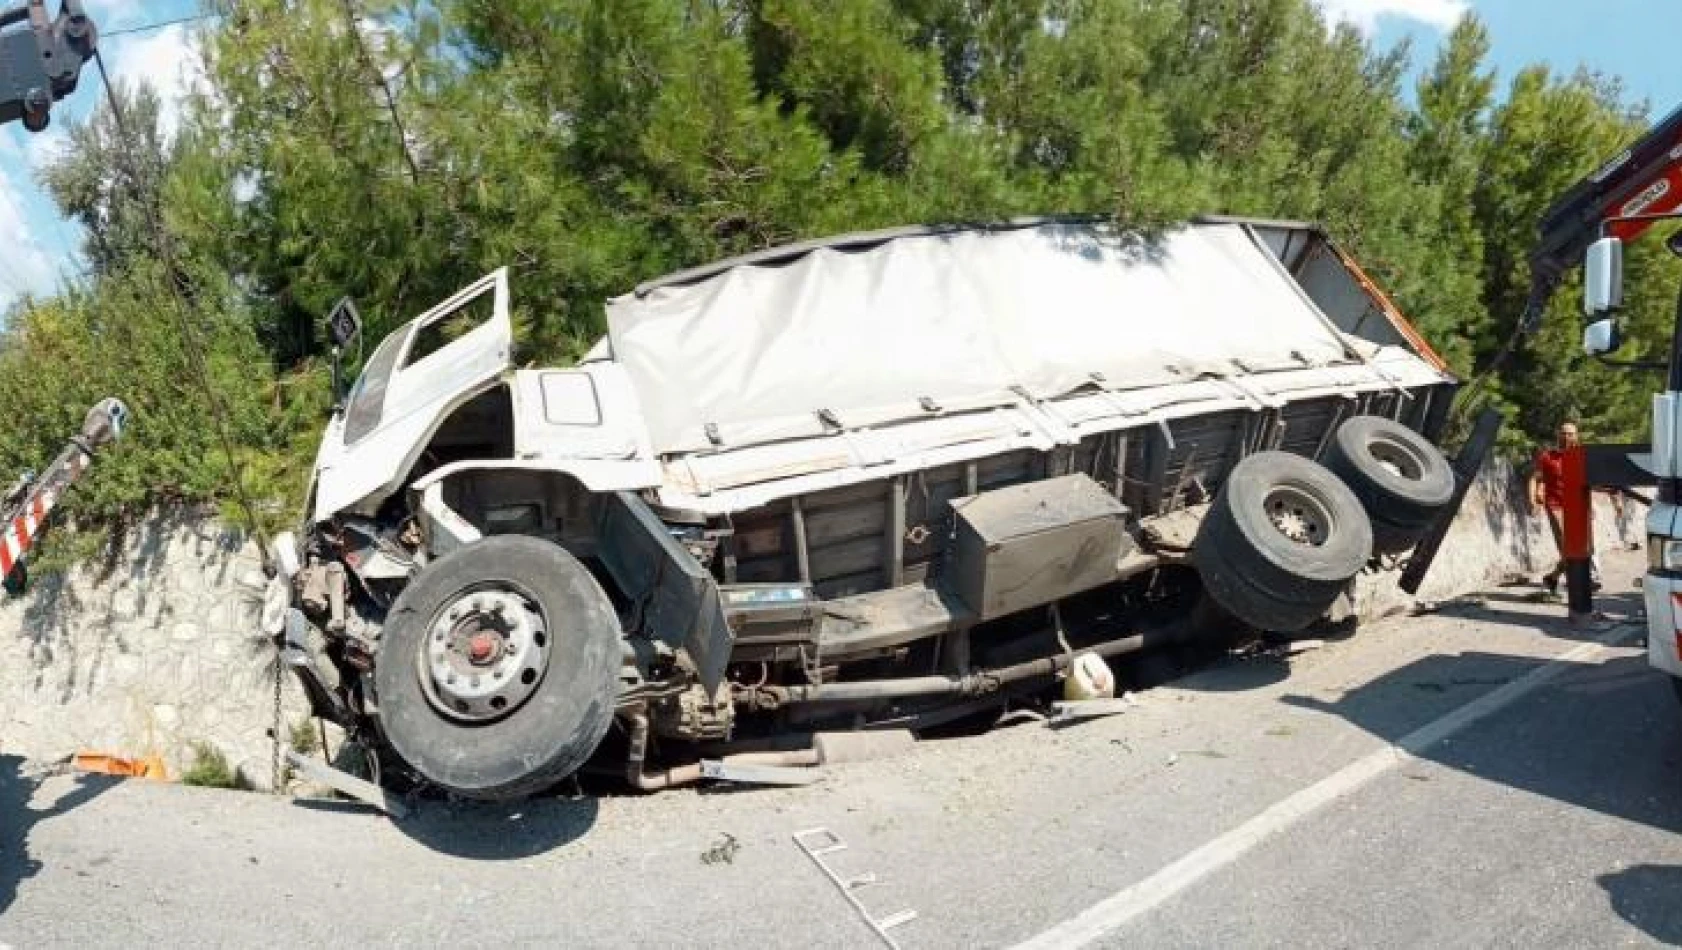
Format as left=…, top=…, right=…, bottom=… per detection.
left=0, top=558, right=1682, bottom=947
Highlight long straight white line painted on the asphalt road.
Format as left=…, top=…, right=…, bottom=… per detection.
left=1014, top=624, right=1640, bottom=950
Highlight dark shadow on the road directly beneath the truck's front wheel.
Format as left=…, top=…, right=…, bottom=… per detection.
left=392, top=795, right=599, bottom=861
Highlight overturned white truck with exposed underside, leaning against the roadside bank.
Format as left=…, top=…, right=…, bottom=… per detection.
left=269, top=219, right=1458, bottom=799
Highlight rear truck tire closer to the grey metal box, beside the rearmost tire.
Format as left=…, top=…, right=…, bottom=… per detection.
left=1191, top=452, right=1373, bottom=632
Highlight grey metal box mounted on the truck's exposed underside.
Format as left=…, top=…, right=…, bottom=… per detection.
left=945, top=474, right=1132, bottom=620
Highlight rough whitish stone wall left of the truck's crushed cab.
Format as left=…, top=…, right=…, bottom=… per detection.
left=0, top=513, right=306, bottom=787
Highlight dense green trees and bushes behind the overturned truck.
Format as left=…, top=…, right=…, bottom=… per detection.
left=0, top=0, right=1674, bottom=545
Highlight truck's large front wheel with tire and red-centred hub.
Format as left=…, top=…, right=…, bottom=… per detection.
left=373, top=535, right=621, bottom=799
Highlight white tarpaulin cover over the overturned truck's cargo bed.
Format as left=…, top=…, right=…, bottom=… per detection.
left=607, top=222, right=1346, bottom=452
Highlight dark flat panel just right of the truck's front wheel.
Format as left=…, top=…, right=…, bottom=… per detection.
left=599, top=491, right=735, bottom=694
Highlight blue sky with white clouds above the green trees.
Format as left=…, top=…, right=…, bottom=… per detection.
left=0, top=0, right=1682, bottom=309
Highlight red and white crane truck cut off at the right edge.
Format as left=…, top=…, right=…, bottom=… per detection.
left=1522, top=100, right=1682, bottom=698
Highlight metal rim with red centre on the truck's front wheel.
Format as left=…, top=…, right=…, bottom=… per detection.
left=415, top=585, right=550, bottom=721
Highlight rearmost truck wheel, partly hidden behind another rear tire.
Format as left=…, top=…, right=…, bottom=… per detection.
left=1325, top=415, right=1455, bottom=553
